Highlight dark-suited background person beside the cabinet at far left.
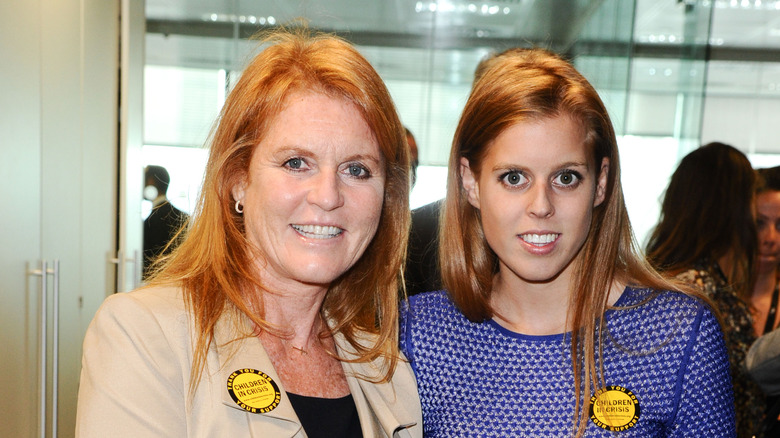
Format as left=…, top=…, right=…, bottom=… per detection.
left=144, top=165, right=189, bottom=278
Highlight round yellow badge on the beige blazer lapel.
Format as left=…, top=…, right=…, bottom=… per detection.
left=227, top=368, right=282, bottom=414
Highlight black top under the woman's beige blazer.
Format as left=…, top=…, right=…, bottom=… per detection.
left=287, top=392, right=363, bottom=438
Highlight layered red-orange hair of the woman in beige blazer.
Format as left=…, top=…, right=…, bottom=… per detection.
left=153, top=30, right=410, bottom=392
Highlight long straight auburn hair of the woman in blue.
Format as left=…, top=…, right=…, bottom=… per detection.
left=439, top=49, right=692, bottom=436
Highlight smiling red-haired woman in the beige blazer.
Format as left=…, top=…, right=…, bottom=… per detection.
left=76, top=31, right=421, bottom=438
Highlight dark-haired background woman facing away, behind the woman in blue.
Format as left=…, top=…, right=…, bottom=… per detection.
left=647, top=142, right=765, bottom=438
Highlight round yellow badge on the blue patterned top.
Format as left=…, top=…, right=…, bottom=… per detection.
left=590, top=385, right=639, bottom=432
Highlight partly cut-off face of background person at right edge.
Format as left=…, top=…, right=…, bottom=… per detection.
left=756, top=190, right=780, bottom=272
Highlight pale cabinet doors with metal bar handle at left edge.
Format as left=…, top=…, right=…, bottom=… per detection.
left=0, top=0, right=120, bottom=437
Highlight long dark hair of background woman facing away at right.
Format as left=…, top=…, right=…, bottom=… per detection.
left=647, top=142, right=758, bottom=303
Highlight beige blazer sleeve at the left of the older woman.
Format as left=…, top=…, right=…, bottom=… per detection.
left=76, top=293, right=189, bottom=438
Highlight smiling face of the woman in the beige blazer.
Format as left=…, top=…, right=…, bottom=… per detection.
left=233, top=93, right=385, bottom=287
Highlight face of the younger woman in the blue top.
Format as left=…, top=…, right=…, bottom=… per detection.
left=461, top=117, right=609, bottom=285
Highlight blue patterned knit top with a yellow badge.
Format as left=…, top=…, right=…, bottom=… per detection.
left=400, top=288, right=735, bottom=437
